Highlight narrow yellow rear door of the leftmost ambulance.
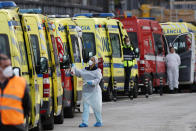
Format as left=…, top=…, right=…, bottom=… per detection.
left=21, top=16, right=40, bottom=127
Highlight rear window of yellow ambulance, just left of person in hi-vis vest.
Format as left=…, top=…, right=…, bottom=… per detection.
left=110, top=34, right=121, bottom=58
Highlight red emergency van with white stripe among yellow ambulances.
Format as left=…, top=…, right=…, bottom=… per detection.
left=117, top=16, right=167, bottom=94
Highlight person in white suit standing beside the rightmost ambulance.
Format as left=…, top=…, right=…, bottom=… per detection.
left=166, top=47, right=181, bottom=93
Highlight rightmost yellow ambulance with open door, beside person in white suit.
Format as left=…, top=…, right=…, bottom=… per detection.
left=161, top=22, right=196, bottom=90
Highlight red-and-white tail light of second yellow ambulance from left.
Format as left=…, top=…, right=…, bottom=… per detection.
left=43, top=74, right=50, bottom=97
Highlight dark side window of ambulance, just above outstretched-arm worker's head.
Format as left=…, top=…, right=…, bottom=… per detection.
left=82, top=32, right=96, bottom=56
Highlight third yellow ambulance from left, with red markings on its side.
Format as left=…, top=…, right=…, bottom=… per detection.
left=48, top=15, right=84, bottom=117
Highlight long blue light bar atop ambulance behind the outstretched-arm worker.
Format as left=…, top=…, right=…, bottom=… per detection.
left=74, top=13, right=115, bottom=18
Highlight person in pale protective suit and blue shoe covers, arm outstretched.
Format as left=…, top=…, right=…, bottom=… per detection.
left=72, top=56, right=102, bottom=127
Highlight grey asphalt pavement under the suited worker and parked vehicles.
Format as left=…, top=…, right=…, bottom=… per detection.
left=50, top=93, right=196, bottom=131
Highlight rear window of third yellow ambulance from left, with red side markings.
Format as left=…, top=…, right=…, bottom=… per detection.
left=71, top=35, right=81, bottom=62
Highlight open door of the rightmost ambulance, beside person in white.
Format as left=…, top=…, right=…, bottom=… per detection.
left=172, top=33, right=195, bottom=84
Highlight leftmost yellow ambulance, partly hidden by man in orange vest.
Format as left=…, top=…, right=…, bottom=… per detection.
left=0, top=2, right=41, bottom=130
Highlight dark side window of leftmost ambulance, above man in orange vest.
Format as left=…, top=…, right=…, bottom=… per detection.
left=0, top=34, right=10, bottom=58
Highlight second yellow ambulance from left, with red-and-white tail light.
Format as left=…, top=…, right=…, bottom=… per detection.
left=20, top=9, right=64, bottom=130
